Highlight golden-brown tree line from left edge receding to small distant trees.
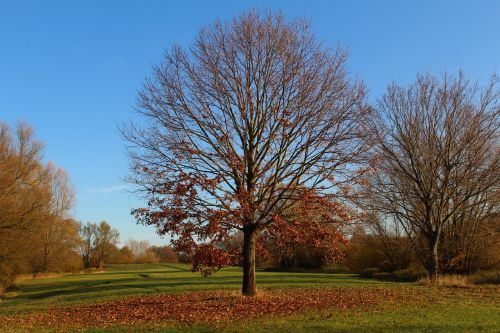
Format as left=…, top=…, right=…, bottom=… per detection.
left=0, top=123, right=177, bottom=287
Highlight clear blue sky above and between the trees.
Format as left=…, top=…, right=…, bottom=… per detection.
left=0, top=0, right=500, bottom=244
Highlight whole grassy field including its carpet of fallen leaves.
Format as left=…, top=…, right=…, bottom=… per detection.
left=0, top=264, right=500, bottom=332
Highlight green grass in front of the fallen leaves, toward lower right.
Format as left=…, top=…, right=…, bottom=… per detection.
left=80, top=299, right=500, bottom=333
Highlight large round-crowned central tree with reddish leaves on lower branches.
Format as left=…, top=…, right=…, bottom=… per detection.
left=122, top=11, right=369, bottom=295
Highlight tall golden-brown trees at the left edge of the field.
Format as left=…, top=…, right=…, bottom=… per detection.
left=0, top=124, right=78, bottom=286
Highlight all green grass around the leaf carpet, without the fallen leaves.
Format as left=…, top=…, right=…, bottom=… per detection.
left=0, top=264, right=500, bottom=332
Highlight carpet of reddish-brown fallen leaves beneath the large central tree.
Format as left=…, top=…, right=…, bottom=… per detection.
left=0, top=287, right=409, bottom=327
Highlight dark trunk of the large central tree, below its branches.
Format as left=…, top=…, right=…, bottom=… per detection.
left=241, top=227, right=257, bottom=296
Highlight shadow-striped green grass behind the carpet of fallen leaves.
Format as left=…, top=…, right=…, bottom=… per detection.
left=0, top=264, right=390, bottom=313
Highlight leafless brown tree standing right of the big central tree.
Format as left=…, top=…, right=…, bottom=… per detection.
left=364, top=73, right=500, bottom=278
